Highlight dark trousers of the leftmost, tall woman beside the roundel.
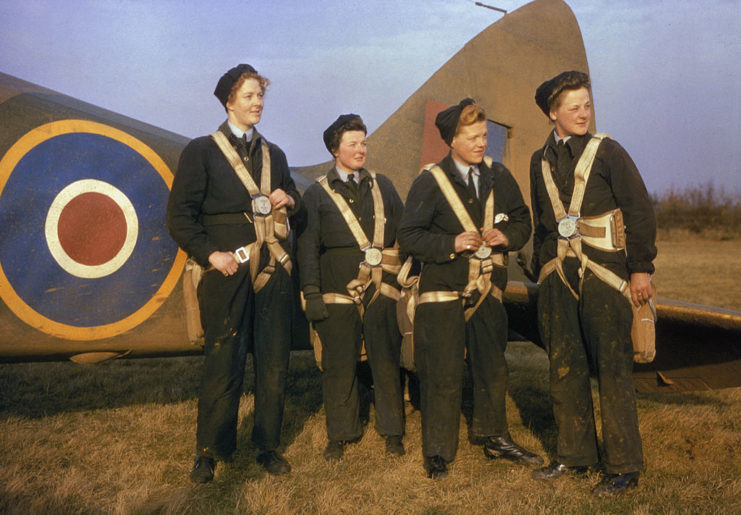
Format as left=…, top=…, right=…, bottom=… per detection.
left=196, top=263, right=293, bottom=458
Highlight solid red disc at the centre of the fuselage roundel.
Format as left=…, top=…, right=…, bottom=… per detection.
left=57, top=192, right=126, bottom=266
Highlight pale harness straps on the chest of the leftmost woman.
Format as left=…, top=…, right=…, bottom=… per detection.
left=211, top=131, right=292, bottom=293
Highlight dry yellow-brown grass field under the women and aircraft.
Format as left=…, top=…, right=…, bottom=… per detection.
left=0, top=240, right=741, bottom=514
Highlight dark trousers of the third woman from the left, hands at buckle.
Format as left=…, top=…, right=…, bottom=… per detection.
left=414, top=297, right=508, bottom=462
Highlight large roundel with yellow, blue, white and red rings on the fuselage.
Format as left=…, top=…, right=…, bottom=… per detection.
left=0, top=120, right=186, bottom=340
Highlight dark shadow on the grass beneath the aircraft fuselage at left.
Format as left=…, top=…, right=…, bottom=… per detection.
left=0, top=351, right=322, bottom=428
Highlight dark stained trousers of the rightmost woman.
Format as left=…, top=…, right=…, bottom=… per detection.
left=538, top=259, right=643, bottom=474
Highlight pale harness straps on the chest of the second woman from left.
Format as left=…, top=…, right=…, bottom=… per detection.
left=316, top=170, right=401, bottom=312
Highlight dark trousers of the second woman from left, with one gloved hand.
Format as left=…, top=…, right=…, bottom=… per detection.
left=314, top=288, right=404, bottom=441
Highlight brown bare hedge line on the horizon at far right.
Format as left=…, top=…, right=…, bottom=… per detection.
left=651, top=183, right=741, bottom=240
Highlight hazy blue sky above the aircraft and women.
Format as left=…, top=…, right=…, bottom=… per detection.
left=0, top=0, right=741, bottom=194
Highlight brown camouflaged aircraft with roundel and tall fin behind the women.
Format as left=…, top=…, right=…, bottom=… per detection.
left=0, top=0, right=741, bottom=391
